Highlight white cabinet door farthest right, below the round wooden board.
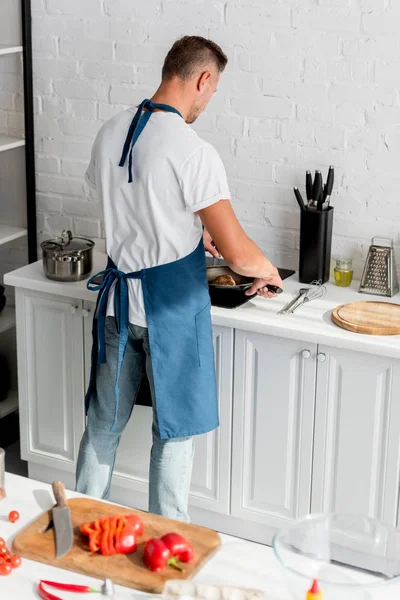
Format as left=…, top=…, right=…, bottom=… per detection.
left=312, top=346, right=400, bottom=524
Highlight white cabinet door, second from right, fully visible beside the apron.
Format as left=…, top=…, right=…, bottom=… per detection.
left=231, top=331, right=316, bottom=532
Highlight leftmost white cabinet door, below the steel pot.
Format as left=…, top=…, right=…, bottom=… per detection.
left=16, top=290, right=84, bottom=471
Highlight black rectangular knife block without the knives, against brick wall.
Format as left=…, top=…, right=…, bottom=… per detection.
left=299, top=206, right=334, bottom=283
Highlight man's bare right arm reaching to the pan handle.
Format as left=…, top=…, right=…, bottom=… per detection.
left=198, top=200, right=282, bottom=296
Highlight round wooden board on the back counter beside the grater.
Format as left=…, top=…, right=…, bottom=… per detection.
left=331, top=302, right=400, bottom=335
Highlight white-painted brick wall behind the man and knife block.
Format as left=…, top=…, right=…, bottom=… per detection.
left=29, top=0, right=400, bottom=274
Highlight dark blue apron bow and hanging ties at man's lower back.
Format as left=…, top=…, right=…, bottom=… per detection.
left=86, top=257, right=142, bottom=430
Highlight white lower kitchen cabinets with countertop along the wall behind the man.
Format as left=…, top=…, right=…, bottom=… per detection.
left=4, top=254, right=400, bottom=544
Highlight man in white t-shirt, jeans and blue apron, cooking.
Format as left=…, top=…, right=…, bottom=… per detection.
left=77, top=36, right=282, bottom=521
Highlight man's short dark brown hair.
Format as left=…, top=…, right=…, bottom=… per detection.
left=162, top=35, right=228, bottom=81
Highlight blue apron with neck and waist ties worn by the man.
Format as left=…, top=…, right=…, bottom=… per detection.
left=85, top=100, right=219, bottom=439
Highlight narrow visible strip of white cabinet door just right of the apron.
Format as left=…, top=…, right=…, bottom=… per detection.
left=190, top=326, right=233, bottom=514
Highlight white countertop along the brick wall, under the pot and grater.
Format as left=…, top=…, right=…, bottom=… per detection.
left=4, top=252, right=400, bottom=358
